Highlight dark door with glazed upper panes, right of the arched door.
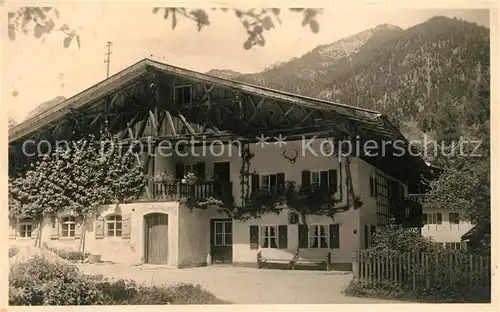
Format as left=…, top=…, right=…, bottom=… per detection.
left=210, top=219, right=233, bottom=264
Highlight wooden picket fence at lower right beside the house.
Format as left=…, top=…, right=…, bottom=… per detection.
left=353, top=250, right=491, bottom=290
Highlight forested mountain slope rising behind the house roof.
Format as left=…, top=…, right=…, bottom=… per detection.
left=207, top=16, right=490, bottom=149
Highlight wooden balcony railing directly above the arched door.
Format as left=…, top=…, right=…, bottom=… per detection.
left=149, top=181, right=233, bottom=204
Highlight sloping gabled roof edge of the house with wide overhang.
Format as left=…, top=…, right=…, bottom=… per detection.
left=9, top=59, right=406, bottom=143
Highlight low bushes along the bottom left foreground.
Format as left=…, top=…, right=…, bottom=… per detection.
left=9, top=257, right=224, bottom=305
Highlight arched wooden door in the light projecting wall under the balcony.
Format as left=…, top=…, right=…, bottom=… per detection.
left=144, top=213, right=168, bottom=264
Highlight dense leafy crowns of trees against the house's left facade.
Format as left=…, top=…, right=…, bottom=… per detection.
left=9, top=133, right=147, bottom=247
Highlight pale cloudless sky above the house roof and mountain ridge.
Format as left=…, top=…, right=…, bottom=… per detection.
left=2, top=3, right=489, bottom=121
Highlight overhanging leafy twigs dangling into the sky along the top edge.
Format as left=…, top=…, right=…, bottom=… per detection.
left=8, top=7, right=322, bottom=50
